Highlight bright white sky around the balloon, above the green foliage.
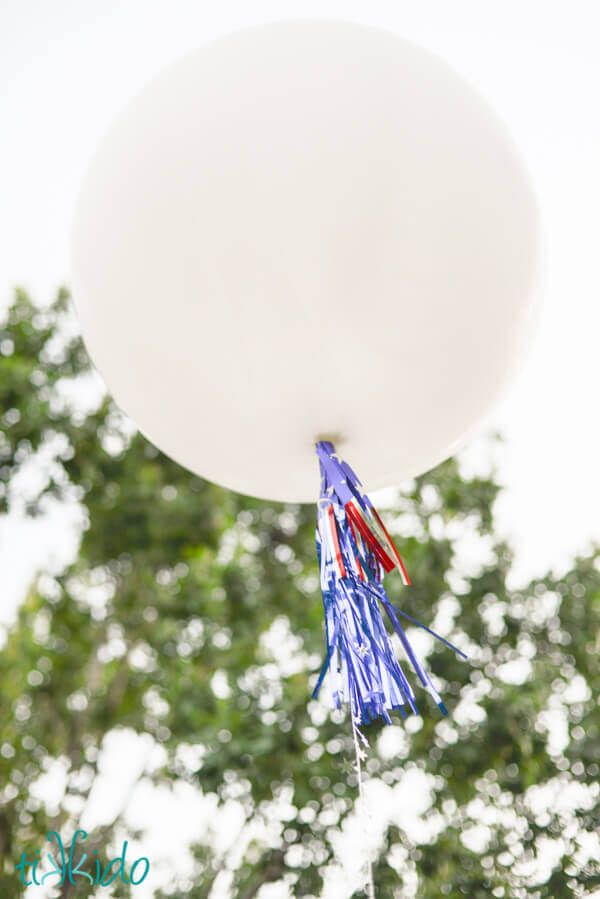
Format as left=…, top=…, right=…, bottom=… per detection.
left=0, top=0, right=600, bottom=896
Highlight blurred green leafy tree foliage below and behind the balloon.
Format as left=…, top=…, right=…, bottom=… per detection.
left=0, top=290, right=600, bottom=899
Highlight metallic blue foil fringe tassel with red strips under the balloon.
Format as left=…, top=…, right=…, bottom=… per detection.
left=313, top=440, right=466, bottom=724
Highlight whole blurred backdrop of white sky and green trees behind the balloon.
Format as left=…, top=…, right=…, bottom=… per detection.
left=0, top=0, right=600, bottom=899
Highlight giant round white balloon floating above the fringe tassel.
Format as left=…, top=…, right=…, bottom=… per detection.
left=72, top=21, right=538, bottom=502
